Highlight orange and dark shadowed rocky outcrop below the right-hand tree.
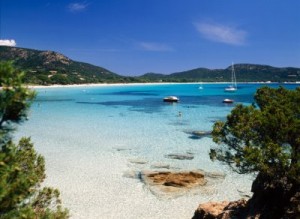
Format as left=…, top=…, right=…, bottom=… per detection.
left=192, top=174, right=300, bottom=219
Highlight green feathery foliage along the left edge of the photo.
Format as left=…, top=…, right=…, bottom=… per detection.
left=0, top=63, right=68, bottom=218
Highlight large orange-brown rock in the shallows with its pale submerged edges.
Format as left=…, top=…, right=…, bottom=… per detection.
left=123, top=165, right=225, bottom=199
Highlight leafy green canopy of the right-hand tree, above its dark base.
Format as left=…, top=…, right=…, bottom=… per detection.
left=210, top=87, right=300, bottom=183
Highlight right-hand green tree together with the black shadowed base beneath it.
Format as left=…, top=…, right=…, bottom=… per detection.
left=210, top=87, right=300, bottom=218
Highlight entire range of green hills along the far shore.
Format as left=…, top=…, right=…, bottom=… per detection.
left=0, top=46, right=300, bottom=85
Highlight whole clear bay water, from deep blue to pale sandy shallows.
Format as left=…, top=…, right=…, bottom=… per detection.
left=15, top=83, right=299, bottom=219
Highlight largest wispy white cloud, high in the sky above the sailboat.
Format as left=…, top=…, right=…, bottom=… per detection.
left=195, top=22, right=247, bottom=45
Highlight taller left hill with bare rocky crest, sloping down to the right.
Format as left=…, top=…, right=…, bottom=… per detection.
left=0, top=46, right=137, bottom=85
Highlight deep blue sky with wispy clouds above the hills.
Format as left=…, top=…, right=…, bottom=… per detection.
left=0, top=0, right=300, bottom=75
